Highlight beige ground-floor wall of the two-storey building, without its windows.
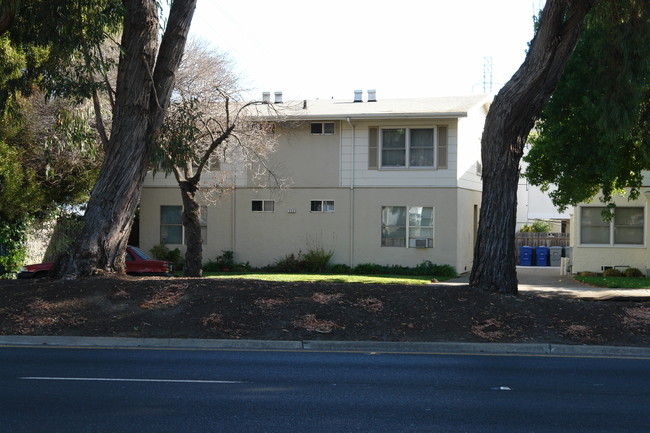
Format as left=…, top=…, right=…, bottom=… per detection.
left=140, top=187, right=470, bottom=272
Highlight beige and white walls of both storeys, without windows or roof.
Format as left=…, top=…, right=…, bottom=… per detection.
left=140, top=110, right=484, bottom=272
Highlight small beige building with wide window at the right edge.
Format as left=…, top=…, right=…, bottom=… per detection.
left=571, top=173, right=650, bottom=274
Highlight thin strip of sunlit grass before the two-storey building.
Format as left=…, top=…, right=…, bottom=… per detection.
left=203, top=272, right=450, bottom=284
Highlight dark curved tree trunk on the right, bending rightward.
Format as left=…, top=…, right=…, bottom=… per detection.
left=470, top=0, right=595, bottom=294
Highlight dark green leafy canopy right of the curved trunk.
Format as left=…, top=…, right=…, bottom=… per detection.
left=524, top=0, right=650, bottom=210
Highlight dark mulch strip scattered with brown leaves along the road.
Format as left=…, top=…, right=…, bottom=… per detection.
left=0, top=277, right=650, bottom=346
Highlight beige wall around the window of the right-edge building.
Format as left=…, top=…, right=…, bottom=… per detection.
left=571, top=188, right=650, bottom=273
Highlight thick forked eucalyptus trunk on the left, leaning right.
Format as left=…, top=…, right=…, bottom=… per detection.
left=57, top=0, right=196, bottom=277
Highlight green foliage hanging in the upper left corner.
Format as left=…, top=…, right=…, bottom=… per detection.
left=0, top=0, right=124, bottom=113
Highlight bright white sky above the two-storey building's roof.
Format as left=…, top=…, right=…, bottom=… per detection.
left=186, top=0, right=544, bottom=101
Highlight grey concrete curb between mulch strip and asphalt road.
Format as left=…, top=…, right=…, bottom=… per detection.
left=0, top=335, right=650, bottom=358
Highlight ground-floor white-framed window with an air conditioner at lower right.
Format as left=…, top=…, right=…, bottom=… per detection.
left=381, top=206, right=434, bottom=248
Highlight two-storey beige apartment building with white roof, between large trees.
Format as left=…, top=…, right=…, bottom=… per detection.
left=140, top=92, right=491, bottom=272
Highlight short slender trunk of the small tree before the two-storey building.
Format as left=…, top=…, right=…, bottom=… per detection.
left=178, top=181, right=203, bottom=277
